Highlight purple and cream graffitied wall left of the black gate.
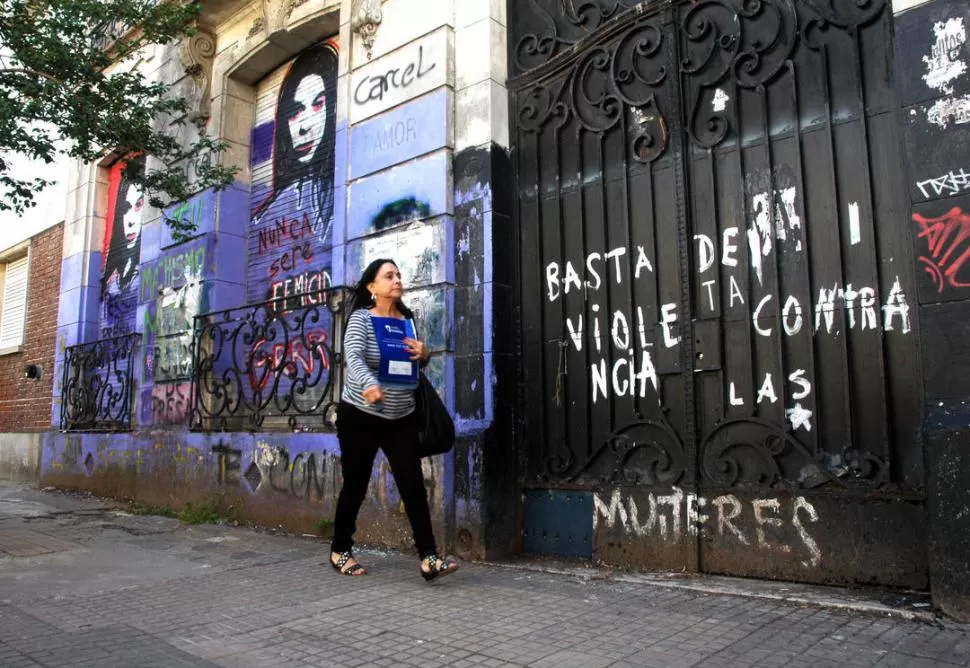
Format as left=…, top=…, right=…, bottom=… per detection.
left=42, top=0, right=510, bottom=554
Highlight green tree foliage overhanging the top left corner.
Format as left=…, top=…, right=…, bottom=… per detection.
left=0, top=0, right=239, bottom=238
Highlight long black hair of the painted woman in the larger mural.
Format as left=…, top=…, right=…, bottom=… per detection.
left=255, top=42, right=338, bottom=233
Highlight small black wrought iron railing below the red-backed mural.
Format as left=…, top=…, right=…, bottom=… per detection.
left=61, top=334, right=141, bottom=431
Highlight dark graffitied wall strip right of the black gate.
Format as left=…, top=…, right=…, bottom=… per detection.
left=895, top=0, right=970, bottom=621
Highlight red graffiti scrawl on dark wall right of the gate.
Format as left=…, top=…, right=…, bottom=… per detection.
left=913, top=207, right=970, bottom=294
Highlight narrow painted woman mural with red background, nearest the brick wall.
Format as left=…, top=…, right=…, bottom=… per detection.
left=99, top=158, right=145, bottom=338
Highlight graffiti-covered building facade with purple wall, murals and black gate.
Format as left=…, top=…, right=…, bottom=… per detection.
left=34, top=0, right=970, bottom=616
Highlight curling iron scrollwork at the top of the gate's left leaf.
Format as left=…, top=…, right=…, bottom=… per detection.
left=518, top=20, right=667, bottom=162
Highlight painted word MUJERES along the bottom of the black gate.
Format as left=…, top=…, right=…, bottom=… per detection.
left=593, top=487, right=822, bottom=568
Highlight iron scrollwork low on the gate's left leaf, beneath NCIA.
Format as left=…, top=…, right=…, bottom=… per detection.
left=543, top=420, right=686, bottom=485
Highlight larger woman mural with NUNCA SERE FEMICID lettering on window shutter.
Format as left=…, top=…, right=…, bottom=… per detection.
left=248, top=40, right=338, bottom=311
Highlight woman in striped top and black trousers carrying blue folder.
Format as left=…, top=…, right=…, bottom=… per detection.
left=330, top=259, right=458, bottom=581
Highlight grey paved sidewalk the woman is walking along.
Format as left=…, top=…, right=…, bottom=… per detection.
left=0, top=483, right=970, bottom=668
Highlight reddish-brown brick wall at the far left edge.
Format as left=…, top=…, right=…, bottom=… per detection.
left=0, top=224, right=64, bottom=432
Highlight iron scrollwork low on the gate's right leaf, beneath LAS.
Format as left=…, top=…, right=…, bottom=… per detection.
left=701, top=417, right=890, bottom=488
